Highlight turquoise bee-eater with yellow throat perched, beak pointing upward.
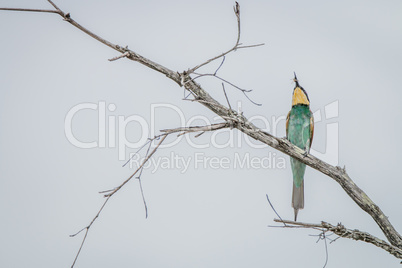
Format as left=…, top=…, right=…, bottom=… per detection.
left=286, top=73, right=314, bottom=221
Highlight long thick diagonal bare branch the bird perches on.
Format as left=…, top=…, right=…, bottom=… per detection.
left=2, top=0, right=402, bottom=262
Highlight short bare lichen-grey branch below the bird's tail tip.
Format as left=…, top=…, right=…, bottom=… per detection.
left=274, top=219, right=402, bottom=259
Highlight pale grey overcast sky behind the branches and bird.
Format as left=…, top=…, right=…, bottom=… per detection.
left=0, top=0, right=402, bottom=267
